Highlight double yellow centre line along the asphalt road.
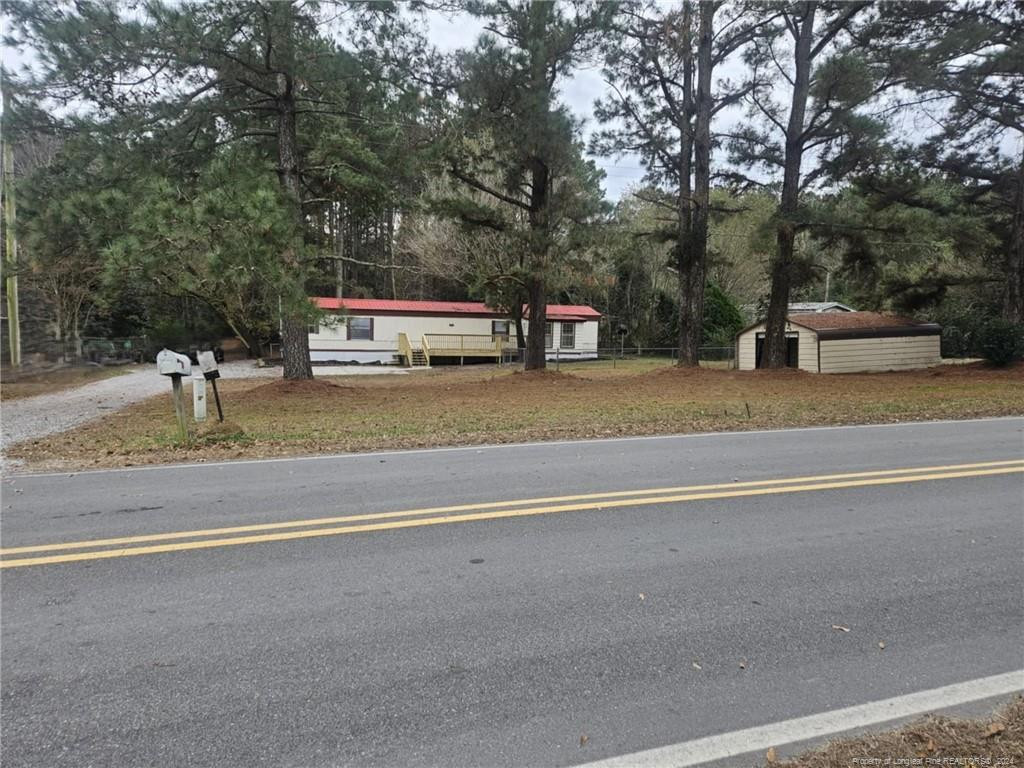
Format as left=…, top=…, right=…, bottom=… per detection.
left=0, top=459, right=1024, bottom=568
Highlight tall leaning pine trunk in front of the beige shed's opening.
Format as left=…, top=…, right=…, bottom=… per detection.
left=763, top=2, right=817, bottom=368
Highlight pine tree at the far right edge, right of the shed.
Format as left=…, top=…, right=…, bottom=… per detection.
left=859, top=0, right=1024, bottom=324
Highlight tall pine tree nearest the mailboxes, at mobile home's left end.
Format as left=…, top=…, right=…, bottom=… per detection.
left=9, top=0, right=419, bottom=379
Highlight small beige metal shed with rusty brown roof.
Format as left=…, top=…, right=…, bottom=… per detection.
left=736, top=311, right=942, bottom=374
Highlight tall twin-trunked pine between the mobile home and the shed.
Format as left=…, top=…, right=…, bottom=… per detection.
left=594, top=0, right=773, bottom=366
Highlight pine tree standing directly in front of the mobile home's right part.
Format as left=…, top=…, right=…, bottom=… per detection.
left=445, top=0, right=613, bottom=369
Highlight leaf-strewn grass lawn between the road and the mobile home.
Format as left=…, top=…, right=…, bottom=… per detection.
left=9, top=359, right=1024, bottom=469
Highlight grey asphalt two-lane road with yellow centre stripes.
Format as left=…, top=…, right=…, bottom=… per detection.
left=0, top=419, right=1024, bottom=766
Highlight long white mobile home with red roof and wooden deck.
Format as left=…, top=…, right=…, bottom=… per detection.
left=309, top=297, right=601, bottom=366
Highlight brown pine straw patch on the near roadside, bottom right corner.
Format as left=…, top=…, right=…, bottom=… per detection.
left=764, top=696, right=1024, bottom=768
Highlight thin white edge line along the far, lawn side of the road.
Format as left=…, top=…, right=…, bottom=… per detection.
left=4, top=416, right=1024, bottom=480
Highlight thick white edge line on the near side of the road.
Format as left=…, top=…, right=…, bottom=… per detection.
left=578, top=670, right=1024, bottom=768
